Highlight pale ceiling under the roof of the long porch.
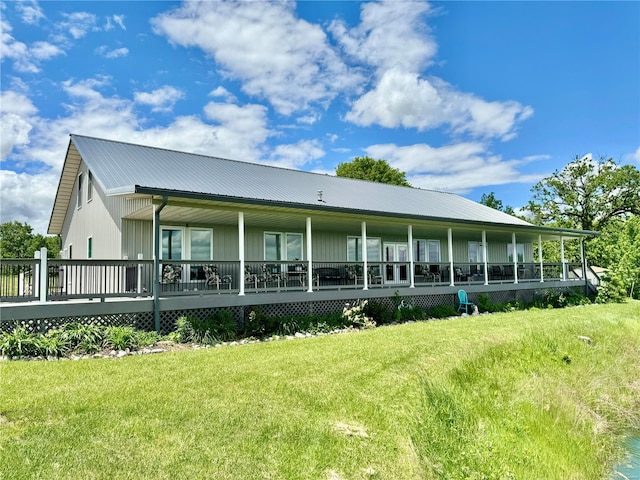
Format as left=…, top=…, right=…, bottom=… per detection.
left=121, top=195, right=575, bottom=243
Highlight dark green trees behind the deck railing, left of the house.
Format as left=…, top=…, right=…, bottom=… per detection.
left=0, top=221, right=60, bottom=258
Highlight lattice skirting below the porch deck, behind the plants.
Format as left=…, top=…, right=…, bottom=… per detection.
left=0, top=281, right=585, bottom=334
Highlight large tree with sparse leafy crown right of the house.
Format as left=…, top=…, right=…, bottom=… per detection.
left=526, top=155, right=640, bottom=230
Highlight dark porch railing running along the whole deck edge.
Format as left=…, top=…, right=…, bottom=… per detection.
left=0, top=252, right=581, bottom=302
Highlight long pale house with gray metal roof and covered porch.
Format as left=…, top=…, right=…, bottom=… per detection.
left=32, top=134, right=594, bottom=330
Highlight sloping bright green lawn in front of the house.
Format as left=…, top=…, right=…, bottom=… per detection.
left=0, top=301, right=640, bottom=480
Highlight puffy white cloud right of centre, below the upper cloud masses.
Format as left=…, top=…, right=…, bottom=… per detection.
left=345, top=68, right=533, bottom=140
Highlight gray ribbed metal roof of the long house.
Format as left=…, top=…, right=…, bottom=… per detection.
left=71, top=135, right=532, bottom=230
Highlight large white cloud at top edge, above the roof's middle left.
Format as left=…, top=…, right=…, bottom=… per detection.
left=152, top=2, right=361, bottom=115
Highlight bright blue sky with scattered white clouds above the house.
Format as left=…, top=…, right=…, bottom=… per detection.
left=0, top=0, right=640, bottom=234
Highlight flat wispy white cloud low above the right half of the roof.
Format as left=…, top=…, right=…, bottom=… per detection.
left=365, top=142, right=547, bottom=194
